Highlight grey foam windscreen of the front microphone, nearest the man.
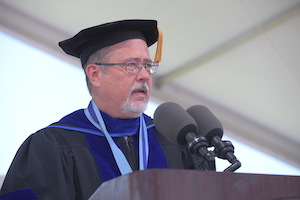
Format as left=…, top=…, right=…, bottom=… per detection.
left=153, top=102, right=197, bottom=144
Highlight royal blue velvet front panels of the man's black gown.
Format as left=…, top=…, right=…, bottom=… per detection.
left=46, top=109, right=167, bottom=182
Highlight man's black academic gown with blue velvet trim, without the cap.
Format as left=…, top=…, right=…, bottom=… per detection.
left=1, top=102, right=193, bottom=200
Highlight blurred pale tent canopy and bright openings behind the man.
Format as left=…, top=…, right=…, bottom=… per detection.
left=0, top=0, right=300, bottom=185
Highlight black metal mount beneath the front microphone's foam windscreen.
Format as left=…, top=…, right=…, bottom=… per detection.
left=185, top=132, right=216, bottom=171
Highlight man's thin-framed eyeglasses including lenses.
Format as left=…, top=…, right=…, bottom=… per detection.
left=94, top=61, right=158, bottom=75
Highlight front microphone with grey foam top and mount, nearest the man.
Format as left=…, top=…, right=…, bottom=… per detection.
left=153, top=102, right=214, bottom=160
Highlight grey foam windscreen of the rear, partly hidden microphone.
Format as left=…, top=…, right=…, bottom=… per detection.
left=186, top=105, right=223, bottom=144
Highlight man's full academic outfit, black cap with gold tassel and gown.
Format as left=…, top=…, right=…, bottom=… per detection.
left=0, top=20, right=197, bottom=200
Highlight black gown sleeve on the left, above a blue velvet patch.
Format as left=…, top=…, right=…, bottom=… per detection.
left=0, top=131, right=76, bottom=200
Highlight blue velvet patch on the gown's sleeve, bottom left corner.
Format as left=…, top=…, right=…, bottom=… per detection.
left=0, top=188, right=38, bottom=200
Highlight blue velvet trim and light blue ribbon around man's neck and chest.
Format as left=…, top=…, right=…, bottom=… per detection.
left=47, top=102, right=167, bottom=182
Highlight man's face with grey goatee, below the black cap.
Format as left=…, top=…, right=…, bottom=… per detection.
left=93, top=39, right=152, bottom=118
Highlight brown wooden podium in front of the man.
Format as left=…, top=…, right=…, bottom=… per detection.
left=90, top=169, right=300, bottom=200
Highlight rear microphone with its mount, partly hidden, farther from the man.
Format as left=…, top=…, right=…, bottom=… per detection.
left=186, top=105, right=241, bottom=172
